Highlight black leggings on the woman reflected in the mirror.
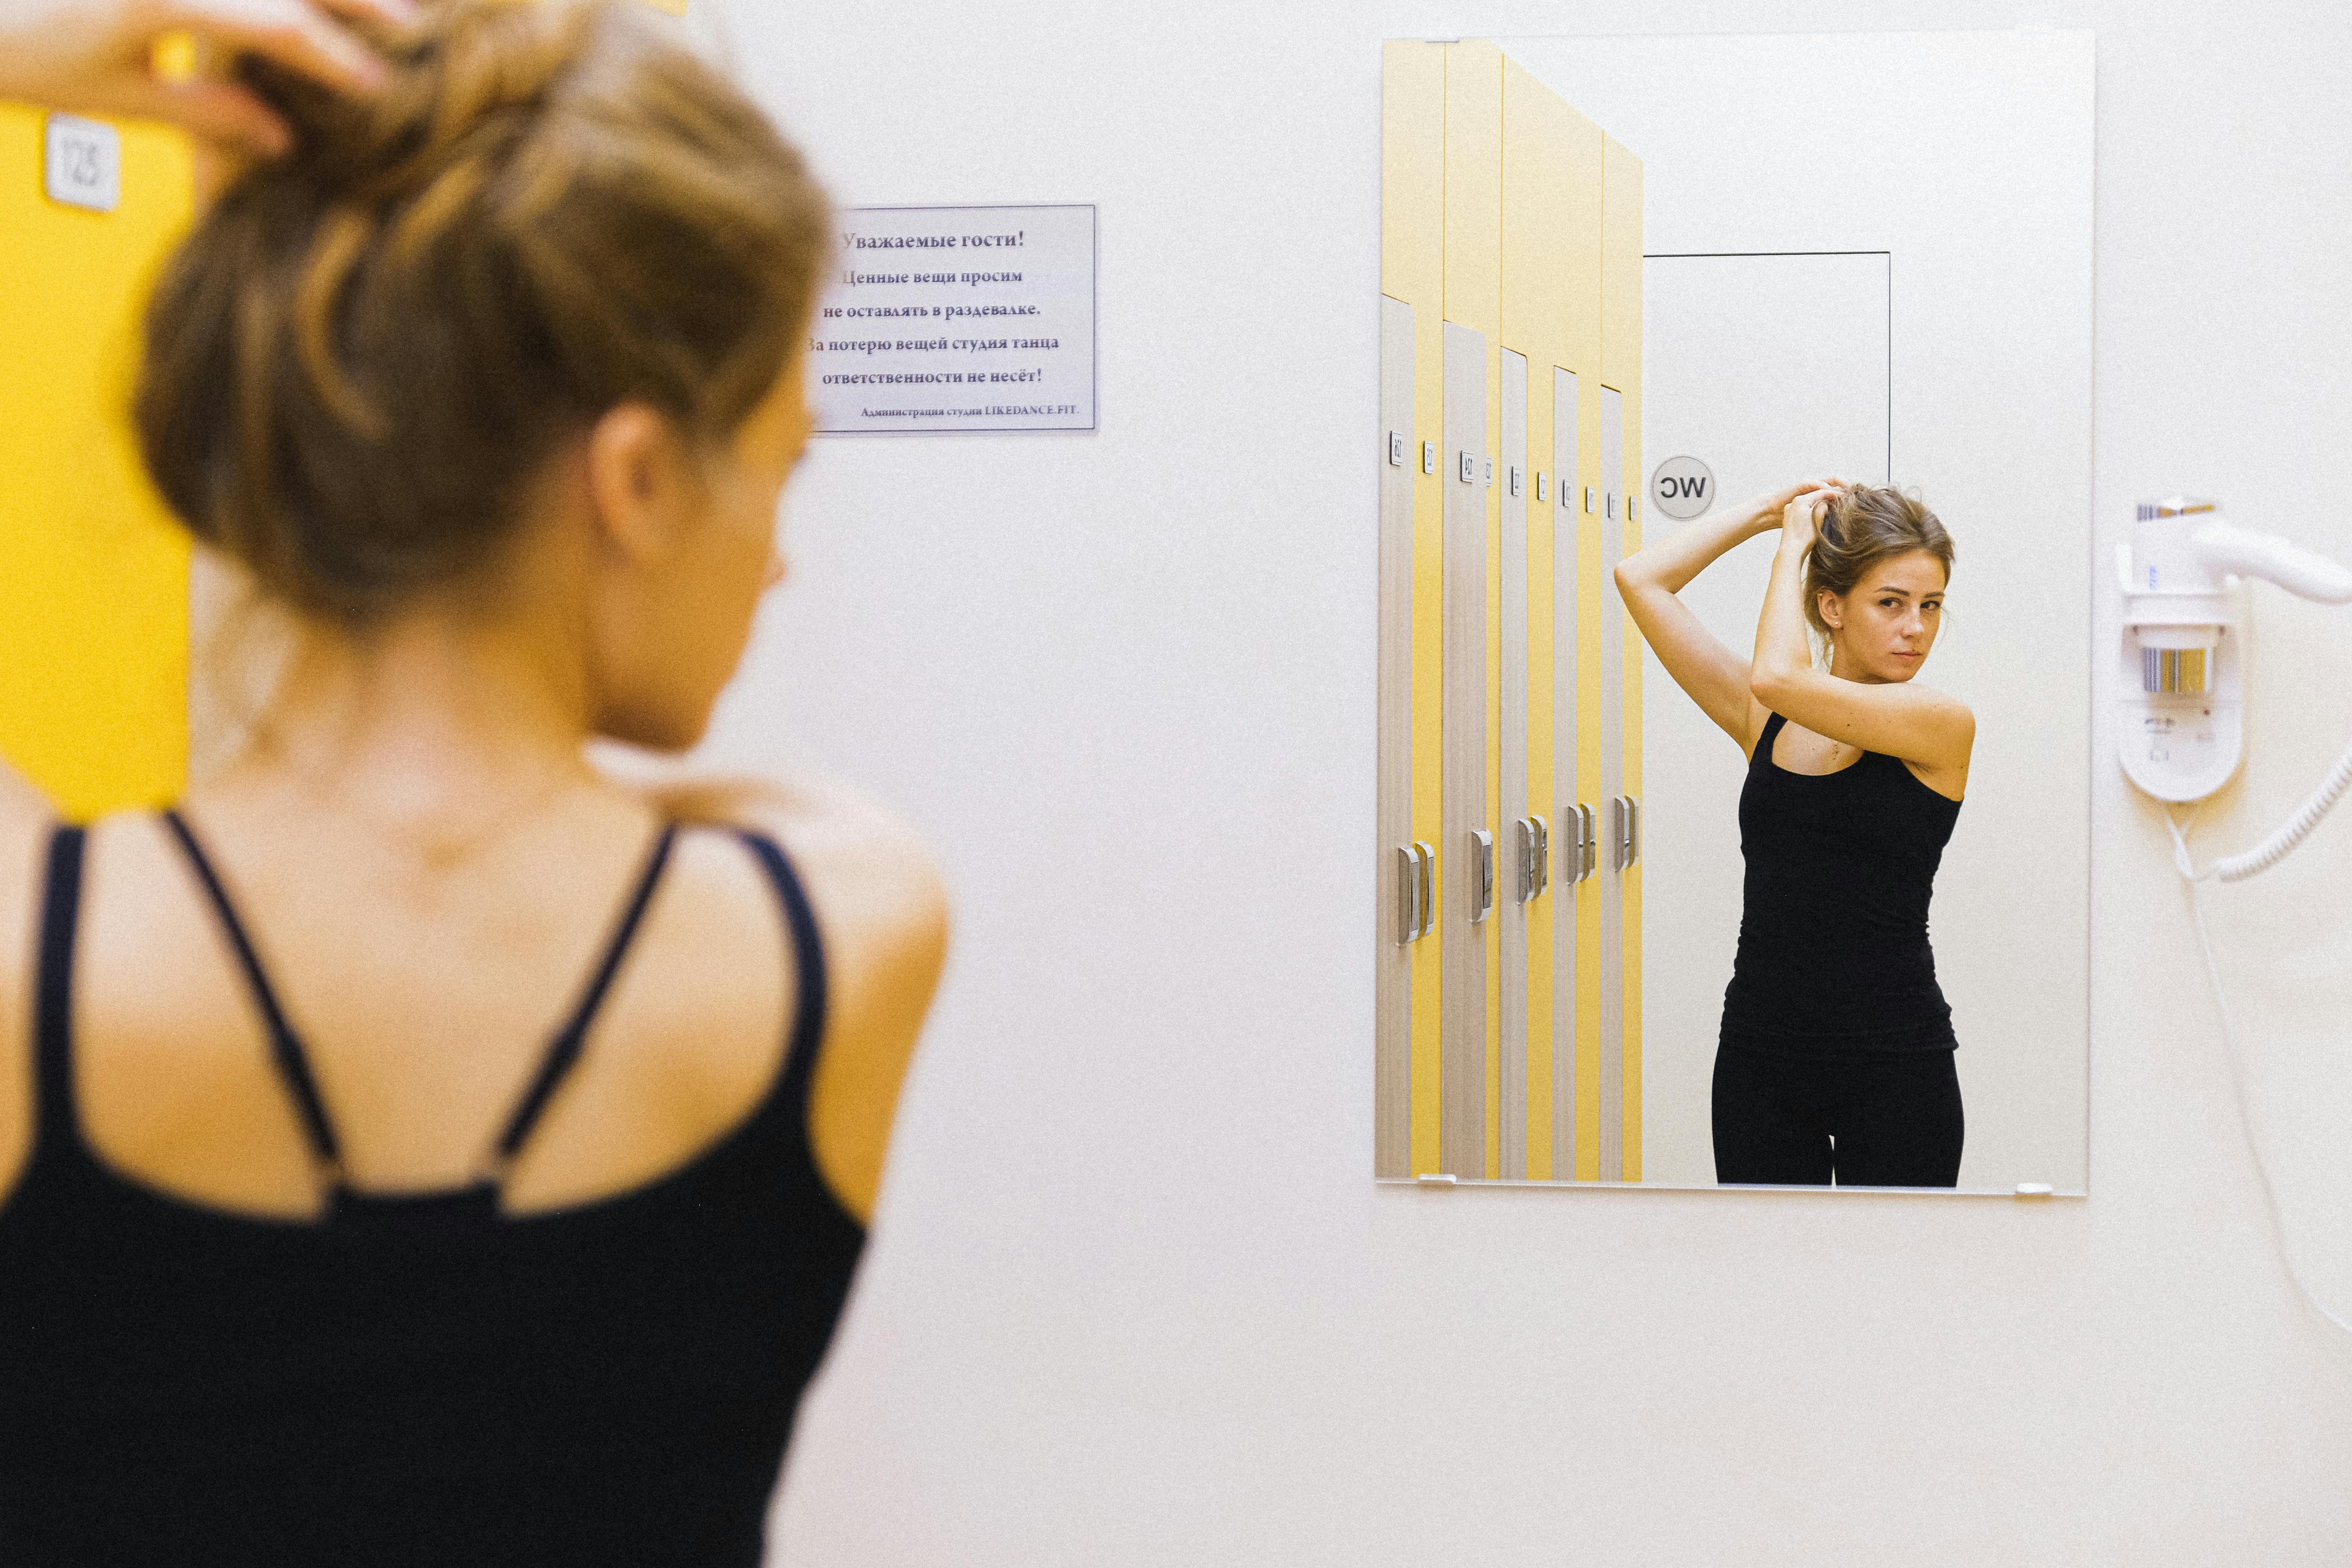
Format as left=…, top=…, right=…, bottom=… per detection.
left=1715, top=1044, right=1964, bottom=1187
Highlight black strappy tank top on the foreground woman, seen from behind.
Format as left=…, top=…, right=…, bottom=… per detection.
left=0, top=820, right=863, bottom=1568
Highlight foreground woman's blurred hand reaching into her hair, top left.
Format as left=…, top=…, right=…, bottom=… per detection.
left=0, top=0, right=416, bottom=158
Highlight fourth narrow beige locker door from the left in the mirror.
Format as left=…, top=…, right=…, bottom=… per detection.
left=1545, top=367, right=1595, bottom=1180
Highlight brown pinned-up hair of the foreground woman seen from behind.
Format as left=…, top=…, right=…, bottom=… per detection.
left=136, top=0, right=828, bottom=625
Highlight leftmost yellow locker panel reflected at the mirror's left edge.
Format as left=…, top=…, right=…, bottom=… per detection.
left=1381, top=42, right=1454, bottom=1176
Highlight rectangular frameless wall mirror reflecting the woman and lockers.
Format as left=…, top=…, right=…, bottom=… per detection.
left=1374, top=31, right=2093, bottom=1194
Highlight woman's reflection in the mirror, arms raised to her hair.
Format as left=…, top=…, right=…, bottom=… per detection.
left=1616, top=479, right=1976, bottom=1187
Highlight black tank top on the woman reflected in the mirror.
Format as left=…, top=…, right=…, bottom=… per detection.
left=1722, top=715, right=1959, bottom=1056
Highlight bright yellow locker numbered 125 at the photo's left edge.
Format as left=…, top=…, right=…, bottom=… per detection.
left=0, top=103, right=193, bottom=818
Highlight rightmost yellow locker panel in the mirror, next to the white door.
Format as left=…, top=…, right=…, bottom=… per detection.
left=1602, top=139, right=1644, bottom=1182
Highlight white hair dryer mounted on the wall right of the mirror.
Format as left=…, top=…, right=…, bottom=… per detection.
left=2117, top=496, right=2352, bottom=882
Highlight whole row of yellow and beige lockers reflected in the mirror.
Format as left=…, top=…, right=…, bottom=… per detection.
left=1374, top=40, right=1642, bottom=1182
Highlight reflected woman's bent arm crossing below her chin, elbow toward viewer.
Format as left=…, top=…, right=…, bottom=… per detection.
left=1750, top=496, right=1976, bottom=783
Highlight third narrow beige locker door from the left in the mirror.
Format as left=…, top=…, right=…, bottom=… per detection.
left=1494, top=348, right=1538, bottom=1180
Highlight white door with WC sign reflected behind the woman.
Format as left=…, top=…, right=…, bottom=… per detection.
left=1642, top=252, right=1893, bottom=1185
